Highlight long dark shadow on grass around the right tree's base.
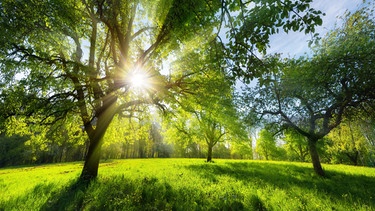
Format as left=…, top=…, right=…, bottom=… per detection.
left=186, top=162, right=375, bottom=208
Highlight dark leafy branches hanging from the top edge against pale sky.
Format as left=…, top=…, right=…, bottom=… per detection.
left=222, top=0, right=324, bottom=83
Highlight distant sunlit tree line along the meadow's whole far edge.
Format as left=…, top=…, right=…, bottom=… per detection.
left=0, top=111, right=375, bottom=167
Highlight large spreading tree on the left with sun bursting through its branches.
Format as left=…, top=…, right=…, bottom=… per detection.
left=0, top=0, right=220, bottom=180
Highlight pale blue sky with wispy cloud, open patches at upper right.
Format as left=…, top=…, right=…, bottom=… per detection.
left=267, top=0, right=363, bottom=57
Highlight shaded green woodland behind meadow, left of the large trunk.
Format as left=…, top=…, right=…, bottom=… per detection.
left=0, top=116, right=87, bottom=166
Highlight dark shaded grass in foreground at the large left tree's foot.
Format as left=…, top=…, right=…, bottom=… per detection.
left=0, top=171, right=265, bottom=210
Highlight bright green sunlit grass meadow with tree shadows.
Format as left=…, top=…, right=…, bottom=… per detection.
left=0, top=159, right=375, bottom=210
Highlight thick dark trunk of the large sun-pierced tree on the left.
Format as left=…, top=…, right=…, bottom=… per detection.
left=80, top=96, right=117, bottom=181
